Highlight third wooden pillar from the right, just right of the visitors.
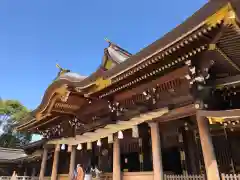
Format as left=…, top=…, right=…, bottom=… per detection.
left=113, top=136, right=121, bottom=180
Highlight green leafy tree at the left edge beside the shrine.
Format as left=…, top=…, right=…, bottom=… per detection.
left=0, top=99, right=31, bottom=148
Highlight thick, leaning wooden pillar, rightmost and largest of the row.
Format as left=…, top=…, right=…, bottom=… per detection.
left=197, top=116, right=220, bottom=180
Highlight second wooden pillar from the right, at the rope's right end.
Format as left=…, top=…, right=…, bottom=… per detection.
left=149, top=122, right=164, bottom=180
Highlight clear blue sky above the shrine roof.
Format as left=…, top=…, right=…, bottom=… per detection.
left=0, top=0, right=207, bottom=109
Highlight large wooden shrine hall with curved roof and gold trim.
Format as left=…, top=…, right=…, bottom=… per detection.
left=17, top=0, right=240, bottom=180
